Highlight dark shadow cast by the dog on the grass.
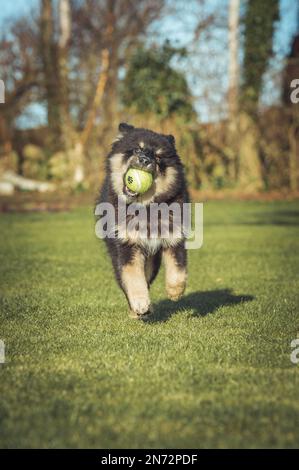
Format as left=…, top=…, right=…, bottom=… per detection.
left=147, top=289, right=254, bottom=323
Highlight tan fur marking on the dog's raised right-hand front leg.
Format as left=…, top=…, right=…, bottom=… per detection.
left=163, top=250, right=187, bottom=300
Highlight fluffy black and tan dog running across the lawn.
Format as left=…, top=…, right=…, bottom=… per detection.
left=97, top=123, right=188, bottom=319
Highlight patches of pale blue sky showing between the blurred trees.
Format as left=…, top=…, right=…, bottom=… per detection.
left=0, top=0, right=299, bottom=125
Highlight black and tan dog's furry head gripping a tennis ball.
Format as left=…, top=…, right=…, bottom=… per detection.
left=108, top=123, right=182, bottom=204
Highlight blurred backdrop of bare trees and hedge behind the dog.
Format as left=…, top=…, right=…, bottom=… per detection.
left=0, top=0, right=299, bottom=192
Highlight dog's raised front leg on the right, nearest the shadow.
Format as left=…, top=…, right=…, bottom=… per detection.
left=163, top=241, right=187, bottom=300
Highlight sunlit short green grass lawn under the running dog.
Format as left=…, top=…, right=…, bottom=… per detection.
left=0, top=202, right=299, bottom=448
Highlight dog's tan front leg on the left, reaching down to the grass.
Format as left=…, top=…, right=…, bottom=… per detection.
left=121, top=250, right=152, bottom=318
